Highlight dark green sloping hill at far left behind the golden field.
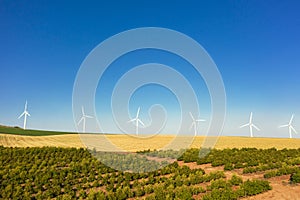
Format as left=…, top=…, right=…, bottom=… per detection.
left=0, top=125, right=77, bottom=136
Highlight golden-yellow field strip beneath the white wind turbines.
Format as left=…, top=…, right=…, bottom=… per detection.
left=0, top=134, right=300, bottom=151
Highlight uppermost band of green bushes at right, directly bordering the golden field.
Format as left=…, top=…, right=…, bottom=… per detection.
left=178, top=148, right=300, bottom=168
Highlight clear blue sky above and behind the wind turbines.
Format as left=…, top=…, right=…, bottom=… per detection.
left=0, top=0, right=300, bottom=137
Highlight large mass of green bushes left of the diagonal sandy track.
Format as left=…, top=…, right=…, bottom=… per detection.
left=0, top=146, right=278, bottom=199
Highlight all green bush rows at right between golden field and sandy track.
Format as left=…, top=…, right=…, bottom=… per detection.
left=178, top=148, right=300, bottom=178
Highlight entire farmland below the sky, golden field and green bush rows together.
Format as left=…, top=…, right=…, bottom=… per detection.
left=0, top=127, right=300, bottom=200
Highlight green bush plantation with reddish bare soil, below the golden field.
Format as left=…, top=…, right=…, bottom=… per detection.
left=0, top=147, right=300, bottom=200
